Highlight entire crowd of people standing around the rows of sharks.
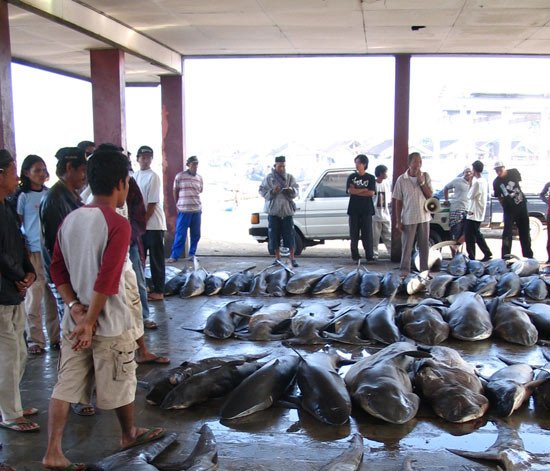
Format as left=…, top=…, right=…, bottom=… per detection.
left=0, top=141, right=550, bottom=469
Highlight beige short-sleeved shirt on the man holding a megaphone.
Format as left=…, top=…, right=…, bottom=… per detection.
left=393, top=170, right=432, bottom=224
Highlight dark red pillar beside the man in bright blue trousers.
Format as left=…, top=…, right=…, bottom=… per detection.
left=160, top=71, right=187, bottom=256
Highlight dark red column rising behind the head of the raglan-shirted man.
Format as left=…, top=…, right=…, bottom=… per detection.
left=90, top=49, right=126, bottom=149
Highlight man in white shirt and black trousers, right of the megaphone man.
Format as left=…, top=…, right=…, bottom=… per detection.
left=464, top=160, right=493, bottom=262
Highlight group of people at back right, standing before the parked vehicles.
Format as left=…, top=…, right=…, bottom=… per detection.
left=259, top=152, right=550, bottom=276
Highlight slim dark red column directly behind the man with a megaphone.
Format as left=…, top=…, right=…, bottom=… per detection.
left=391, top=54, right=411, bottom=262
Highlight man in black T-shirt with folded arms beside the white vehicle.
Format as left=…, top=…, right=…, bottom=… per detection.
left=346, top=154, right=376, bottom=261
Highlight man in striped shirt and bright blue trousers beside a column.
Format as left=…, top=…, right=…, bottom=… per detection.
left=168, top=155, right=203, bottom=263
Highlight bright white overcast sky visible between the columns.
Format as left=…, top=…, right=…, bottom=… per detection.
left=12, top=56, right=550, bottom=187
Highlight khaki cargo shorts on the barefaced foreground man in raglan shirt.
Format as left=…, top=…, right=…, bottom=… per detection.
left=52, top=332, right=137, bottom=410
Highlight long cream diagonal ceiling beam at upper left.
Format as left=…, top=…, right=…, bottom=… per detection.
left=8, top=0, right=182, bottom=74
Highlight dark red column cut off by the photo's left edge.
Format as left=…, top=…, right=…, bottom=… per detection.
left=0, top=0, right=15, bottom=156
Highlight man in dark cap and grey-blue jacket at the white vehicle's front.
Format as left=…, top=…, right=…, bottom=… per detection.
left=260, top=155, right=298, bottom=267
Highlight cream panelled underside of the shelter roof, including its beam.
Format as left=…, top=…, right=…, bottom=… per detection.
left=8, top=0, right=550, bottom=83
